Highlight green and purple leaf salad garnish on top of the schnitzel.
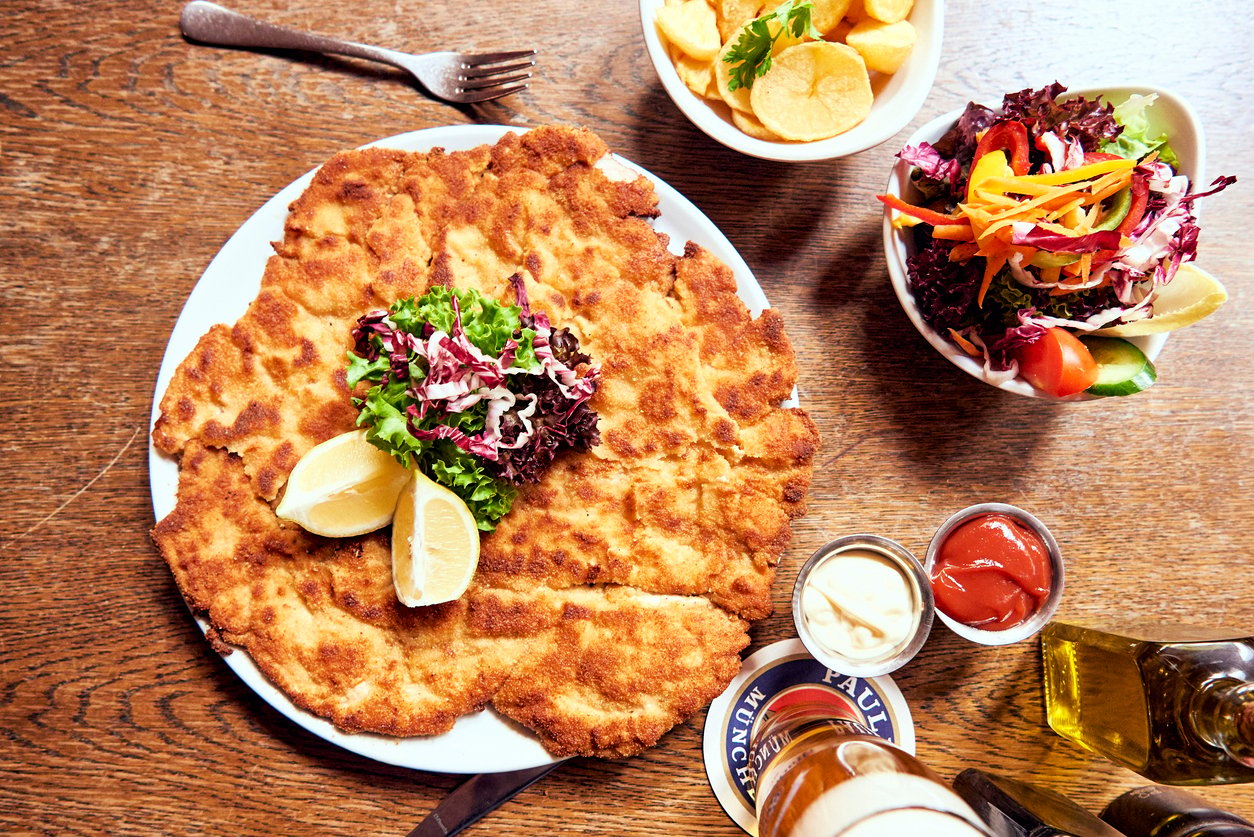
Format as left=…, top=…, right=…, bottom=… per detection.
left=347, top=279, right=601, bottom=532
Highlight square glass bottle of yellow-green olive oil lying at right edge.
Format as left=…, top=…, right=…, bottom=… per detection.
left=1041, top=621, right=1254, bottom=784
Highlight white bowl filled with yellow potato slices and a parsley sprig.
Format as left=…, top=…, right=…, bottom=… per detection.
left=640, top=0, right=944, bottom=162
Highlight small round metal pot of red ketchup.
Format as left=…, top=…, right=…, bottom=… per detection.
left=932, top=514, right=1053, bottom=631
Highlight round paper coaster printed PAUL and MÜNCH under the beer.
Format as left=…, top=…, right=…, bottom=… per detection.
left=702, top=639, right=914, bottom=837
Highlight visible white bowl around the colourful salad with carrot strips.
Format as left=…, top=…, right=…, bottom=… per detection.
left=884, top=84, right=1205, bottom=402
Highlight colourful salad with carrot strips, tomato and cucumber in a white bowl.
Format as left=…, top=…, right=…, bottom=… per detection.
left=879, top=83, right=1236, bottom=397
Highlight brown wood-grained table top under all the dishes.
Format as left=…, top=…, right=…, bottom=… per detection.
left=0, top=0, right=1254, bottom=836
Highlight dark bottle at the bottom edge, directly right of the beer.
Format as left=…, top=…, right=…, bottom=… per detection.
left=953, top=768, right=1125, bottom=837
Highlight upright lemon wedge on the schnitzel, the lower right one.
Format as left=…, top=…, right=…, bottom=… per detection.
left=393, top=472, right=479, bottom=607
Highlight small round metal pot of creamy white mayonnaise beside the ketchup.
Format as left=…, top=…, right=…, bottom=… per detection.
left=801, top=548, right=920, bottom=661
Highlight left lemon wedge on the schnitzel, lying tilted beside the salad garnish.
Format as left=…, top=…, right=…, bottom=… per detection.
left=275, top=430, right=409, bottom=537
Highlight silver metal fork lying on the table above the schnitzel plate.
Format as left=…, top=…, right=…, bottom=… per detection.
left=178, top=0, right=535, bottom=104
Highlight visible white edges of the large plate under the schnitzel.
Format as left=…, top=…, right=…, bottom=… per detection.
left=148, top=125, right=770, bottom=773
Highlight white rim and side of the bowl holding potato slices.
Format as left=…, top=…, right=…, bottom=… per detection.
left=640, top=0, right=944, bottom=162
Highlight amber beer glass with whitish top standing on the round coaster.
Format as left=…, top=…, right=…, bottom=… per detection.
left=750, top=703, right=991, bottom=837
